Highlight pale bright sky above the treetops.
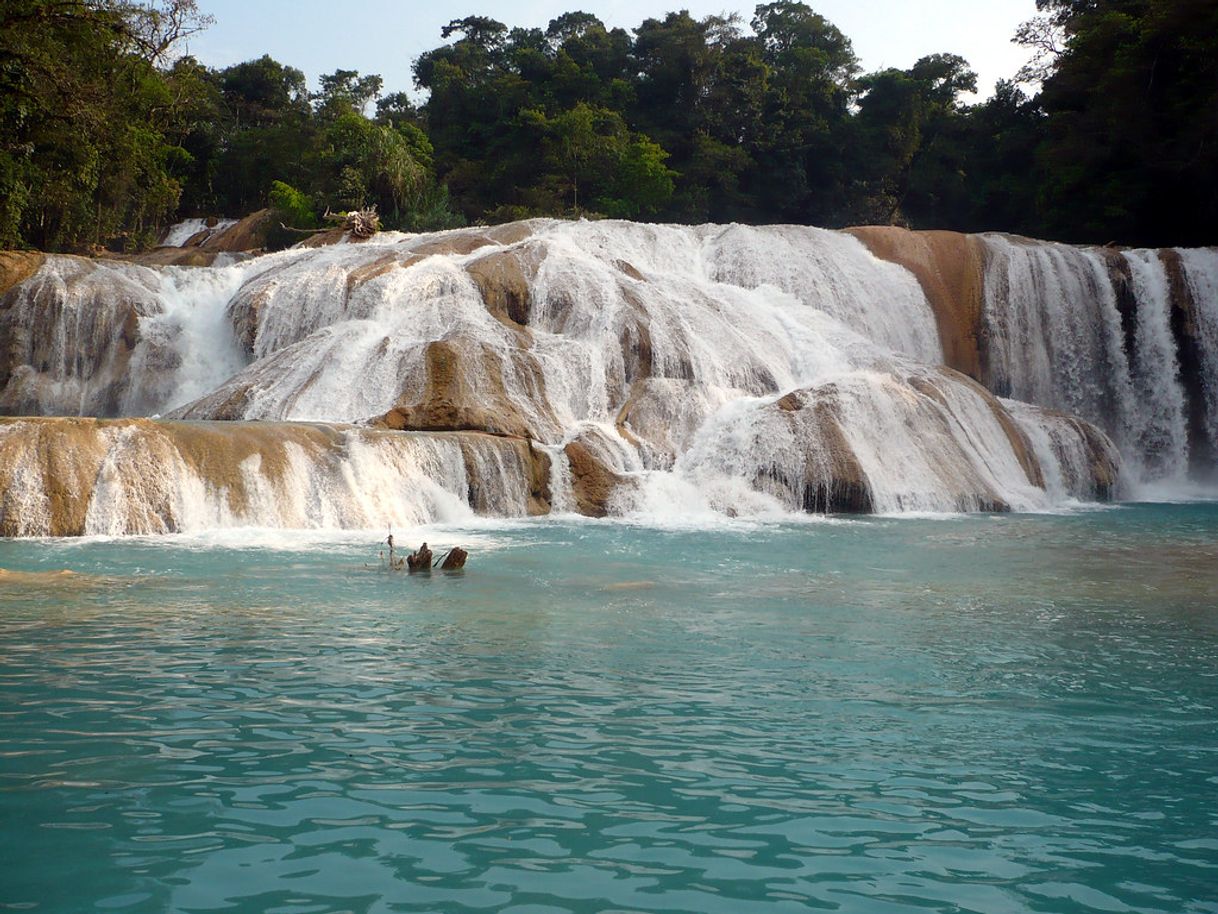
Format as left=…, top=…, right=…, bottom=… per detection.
left=188, top=0, right=1037, bottom=97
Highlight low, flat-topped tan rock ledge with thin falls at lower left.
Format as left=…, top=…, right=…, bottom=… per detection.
left=0, top=418, right=548, bottom=536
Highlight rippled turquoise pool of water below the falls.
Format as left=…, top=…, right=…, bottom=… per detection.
left=0, top=506, right=1218, bottom=914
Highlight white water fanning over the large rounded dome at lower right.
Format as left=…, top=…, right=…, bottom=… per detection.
left=677, top=366, right=1050, bottom=513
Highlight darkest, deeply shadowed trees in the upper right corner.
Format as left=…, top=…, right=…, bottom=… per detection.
left=1037, top=0, right=1218, bottom=245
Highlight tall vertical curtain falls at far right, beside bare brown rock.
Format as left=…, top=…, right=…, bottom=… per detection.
left=983, top=235, right=1218, bottom=487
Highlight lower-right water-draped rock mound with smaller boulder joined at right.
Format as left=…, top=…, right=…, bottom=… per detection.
left=691, top=368, right=1118, bottom=513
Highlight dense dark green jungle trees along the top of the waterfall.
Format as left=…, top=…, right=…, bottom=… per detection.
left=0, top=0, right=1218, bottom=250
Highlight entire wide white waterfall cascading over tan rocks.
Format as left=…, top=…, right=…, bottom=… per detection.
left=0, top=221, right=1218, bottom=533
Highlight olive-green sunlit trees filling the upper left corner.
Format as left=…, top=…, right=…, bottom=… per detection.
left=0, top=0, right=214, bottom=250
